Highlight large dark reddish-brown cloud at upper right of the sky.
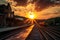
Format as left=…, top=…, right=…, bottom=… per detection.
left=35, top=0, right=60, bottom=11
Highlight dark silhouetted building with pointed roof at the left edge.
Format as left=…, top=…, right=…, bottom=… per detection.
left=0, top=3, right=14, bottom=26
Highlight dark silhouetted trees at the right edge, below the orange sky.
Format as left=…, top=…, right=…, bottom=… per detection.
left=45, top=17, right=60, bottom=26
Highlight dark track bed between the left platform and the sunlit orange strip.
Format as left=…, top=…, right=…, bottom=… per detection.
left=0, top=27, right=28, bottom=40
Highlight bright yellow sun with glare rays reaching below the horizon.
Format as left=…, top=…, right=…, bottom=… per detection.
left=24, top=11, right=37, bottom=24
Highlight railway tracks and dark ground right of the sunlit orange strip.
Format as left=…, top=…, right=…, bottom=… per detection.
left=26, top=25, right=60, bottom=40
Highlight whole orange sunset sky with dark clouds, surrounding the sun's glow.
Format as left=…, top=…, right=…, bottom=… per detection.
left=0, top=0, right=60, bottom=19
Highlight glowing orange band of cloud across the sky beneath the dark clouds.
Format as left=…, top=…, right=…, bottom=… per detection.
left=8, top=0, right=60, bottom=19
